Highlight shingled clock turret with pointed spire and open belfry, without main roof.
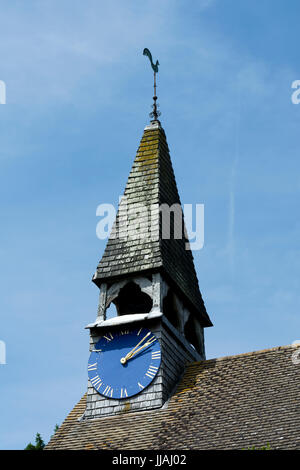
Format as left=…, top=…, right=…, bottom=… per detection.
left=82, top=53, right=212, bottom=419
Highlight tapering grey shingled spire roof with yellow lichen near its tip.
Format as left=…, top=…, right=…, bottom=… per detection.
left=93, top=125, right=212, bottom=326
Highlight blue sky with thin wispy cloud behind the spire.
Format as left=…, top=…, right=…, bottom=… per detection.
left=0, top=0, right=300, bottom=449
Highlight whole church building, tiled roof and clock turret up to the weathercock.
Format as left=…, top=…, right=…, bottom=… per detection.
left=45, top=49, right=300, bottom=452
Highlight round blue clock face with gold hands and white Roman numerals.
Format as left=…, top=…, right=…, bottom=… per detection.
left=88, top=328, right=161, bottom=399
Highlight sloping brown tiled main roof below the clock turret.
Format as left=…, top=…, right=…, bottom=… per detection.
left=46, top=346, right=300, bottom=450
